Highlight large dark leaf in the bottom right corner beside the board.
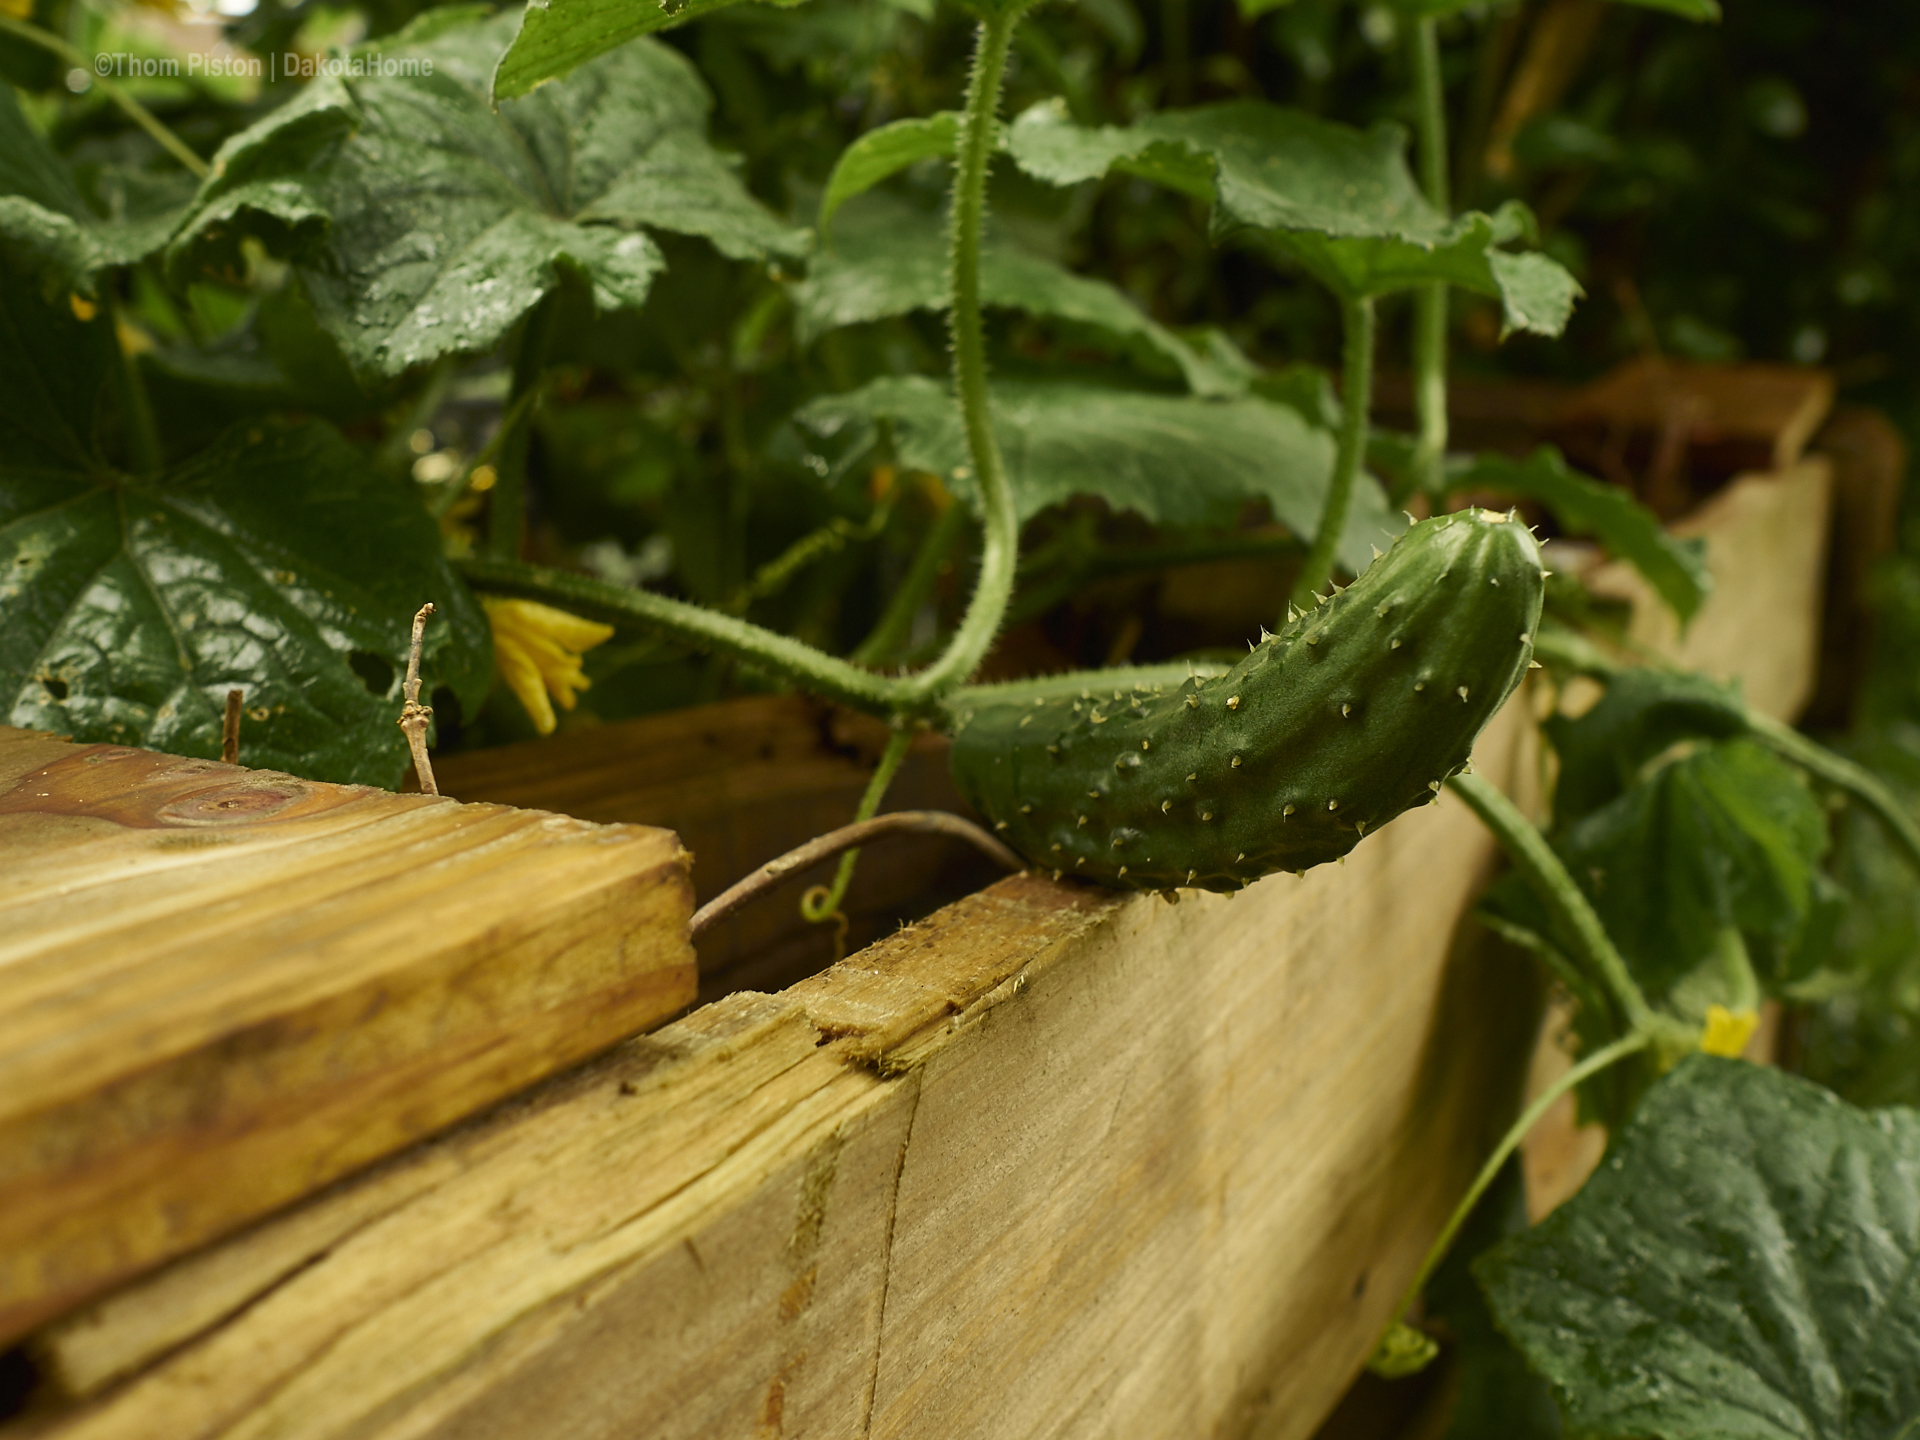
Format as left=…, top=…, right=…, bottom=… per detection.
left=1475, top=1056, right=1920, bottom=1440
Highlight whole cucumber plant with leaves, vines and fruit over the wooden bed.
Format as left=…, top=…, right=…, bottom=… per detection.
left=11, top=0, right=1920, bottom=1436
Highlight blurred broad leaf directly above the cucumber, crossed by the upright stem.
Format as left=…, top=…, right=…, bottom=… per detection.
left=797, top=376, right=1405, bottom=574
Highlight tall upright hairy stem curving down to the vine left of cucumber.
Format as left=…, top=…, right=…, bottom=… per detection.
left=904, top=6, right=1021, bottom=707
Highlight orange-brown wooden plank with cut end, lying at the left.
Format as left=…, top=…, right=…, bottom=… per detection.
left=0, top=730, right=693, bottom=1338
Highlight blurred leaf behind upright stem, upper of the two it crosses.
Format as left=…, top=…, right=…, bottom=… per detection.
left=793, top=196, right=1246, bottom=396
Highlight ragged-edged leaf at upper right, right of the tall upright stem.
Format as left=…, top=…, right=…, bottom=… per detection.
left=1008, top=100, right=1580, bottom=334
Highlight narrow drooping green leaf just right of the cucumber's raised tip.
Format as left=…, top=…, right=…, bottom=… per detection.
left=1446, top=449, right=1713, bottom=624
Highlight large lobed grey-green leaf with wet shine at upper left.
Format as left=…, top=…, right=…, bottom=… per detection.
left=173, top=12, right=806, bottom=374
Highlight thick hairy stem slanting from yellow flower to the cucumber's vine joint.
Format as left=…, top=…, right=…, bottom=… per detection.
left=457, top=555, right=902, bottom=718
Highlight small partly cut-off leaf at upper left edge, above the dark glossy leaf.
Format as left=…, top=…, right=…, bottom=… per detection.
left=0, top=83, right=182, bottom=296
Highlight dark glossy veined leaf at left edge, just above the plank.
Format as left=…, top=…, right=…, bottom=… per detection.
left=0, top=275, right=492, bottom=785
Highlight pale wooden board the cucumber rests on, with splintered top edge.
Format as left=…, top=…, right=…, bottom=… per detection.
left=6, top=705, right=1538, bottom=1440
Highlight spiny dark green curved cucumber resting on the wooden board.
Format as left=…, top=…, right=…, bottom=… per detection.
left=950, top=511, right=1544, bottom=891
